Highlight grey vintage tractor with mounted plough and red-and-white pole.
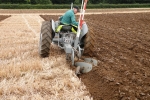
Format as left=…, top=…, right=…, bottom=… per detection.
left=39, top=0, right=97, bottom=74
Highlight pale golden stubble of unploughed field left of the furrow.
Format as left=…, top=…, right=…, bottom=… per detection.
left=0, top=15, right=92, bottom=100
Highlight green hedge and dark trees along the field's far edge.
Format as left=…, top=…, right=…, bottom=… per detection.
left=0, top=0, right=150, bottom=9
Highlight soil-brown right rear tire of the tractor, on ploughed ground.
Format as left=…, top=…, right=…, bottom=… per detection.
left=83, top=30, right=95, bottom=57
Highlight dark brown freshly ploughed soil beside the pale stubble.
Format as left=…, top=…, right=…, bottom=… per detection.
left=41, top=13, right=150, bottom=100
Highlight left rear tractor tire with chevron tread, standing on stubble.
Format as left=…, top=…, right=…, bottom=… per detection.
left=39, top=21, right=52, bottom=58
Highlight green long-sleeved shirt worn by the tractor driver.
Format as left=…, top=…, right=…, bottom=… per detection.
left=60, top=10, right=78, bottom=26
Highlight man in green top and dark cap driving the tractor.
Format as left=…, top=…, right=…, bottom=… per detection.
left=56, top=6, right=80, bottom=33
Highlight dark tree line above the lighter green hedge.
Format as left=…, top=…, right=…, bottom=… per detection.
left=0, top=0, right=150, bottom=4
